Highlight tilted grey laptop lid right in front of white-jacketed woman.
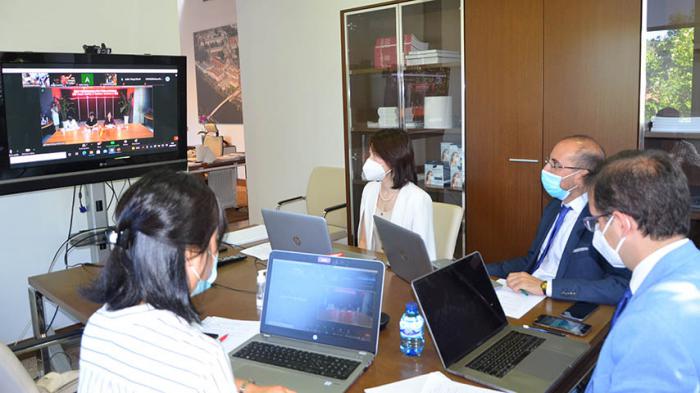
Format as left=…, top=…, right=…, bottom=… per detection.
left=374, top=216, right=452, bottom=282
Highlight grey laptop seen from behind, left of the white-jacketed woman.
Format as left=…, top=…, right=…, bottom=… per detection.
left=261, top=209, right=368, bottom=259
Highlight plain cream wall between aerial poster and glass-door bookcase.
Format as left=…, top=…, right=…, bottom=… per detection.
left=237, top=0, right=377, bottom=223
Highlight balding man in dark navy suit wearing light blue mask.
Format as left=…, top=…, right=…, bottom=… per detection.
left=487, top=135, right=630, bottom=304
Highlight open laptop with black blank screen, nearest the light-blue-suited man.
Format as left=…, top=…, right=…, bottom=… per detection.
left=411, top=252, right=589, bottom=392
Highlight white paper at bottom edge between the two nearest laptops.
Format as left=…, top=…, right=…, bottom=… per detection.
left=365, top=371, right=497, bottom=393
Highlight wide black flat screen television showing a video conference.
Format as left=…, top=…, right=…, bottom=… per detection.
left=0, top=52, right=187, bottom=195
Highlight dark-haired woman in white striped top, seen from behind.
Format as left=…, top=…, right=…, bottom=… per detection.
left=78, top=171, right=290, bottom=393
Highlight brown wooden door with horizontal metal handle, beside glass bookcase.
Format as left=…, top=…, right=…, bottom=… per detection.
left=465, top=0, right=543, bottom=262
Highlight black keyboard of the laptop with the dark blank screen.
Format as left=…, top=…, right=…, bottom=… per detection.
left=467, top=331, right=544, bottom=378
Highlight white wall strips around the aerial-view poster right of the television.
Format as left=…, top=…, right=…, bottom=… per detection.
left=177, top=0, right=247, bottom=178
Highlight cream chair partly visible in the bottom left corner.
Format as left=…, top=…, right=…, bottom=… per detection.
left=0, top=342, right=78, bottom=393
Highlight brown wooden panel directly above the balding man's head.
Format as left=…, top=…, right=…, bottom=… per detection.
left=543, top=0, right=642, bottom=162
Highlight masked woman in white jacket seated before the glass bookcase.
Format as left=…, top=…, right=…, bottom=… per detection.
left=358, top=130, right=436, bottom=260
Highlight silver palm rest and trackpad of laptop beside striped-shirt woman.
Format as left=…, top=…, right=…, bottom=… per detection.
left=234, top=359, right=338, bottom=392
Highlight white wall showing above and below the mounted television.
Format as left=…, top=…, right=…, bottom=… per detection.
left=0, top=0, right=180, bottom=343
